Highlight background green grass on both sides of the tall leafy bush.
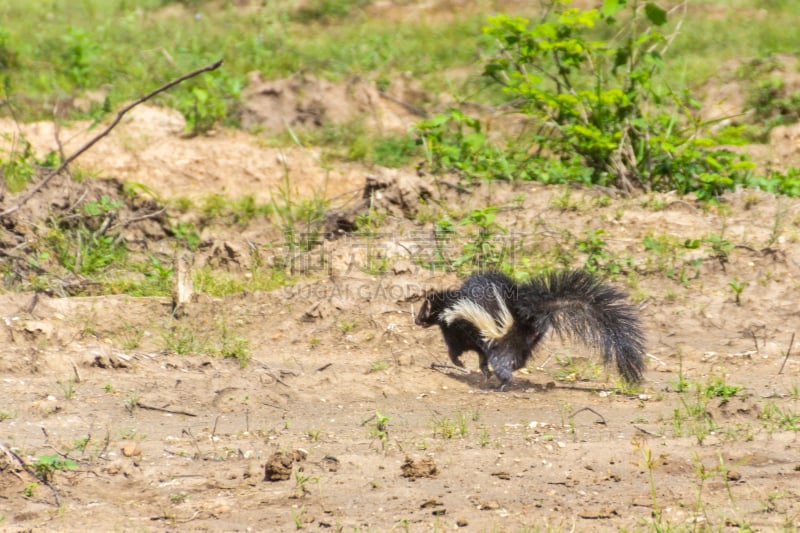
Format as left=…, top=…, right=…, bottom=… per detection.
left=0, top=0, right=800, bottom=123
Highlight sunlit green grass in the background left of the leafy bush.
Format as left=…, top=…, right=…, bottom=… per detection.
left=0, top=0, right=484, bottom=119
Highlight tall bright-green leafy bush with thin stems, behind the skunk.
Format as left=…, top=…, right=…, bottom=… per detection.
left=484, top=0, right=752, bottom=198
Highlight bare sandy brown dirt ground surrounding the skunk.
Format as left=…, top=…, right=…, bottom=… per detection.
left=0, top=88, right=800, bottom=531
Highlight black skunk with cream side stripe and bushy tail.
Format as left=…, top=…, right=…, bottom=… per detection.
left=416, top=270, right=644, bottom=390
